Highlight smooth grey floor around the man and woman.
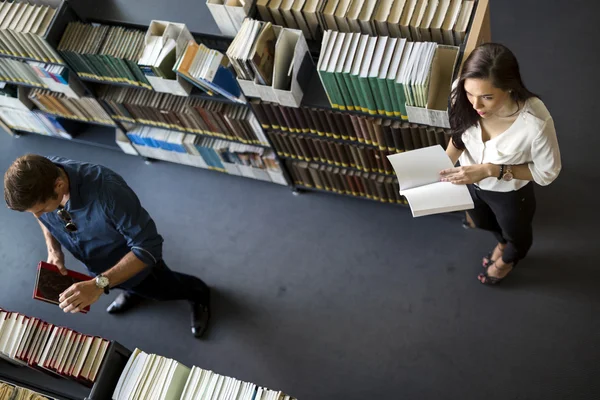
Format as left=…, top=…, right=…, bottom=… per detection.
left=0, top=0, right=600, bottom=400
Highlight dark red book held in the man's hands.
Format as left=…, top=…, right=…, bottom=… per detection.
left=33, top=261, right=92, bottom=314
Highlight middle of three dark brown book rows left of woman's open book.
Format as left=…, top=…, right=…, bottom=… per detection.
left=269, top=132, right=394, bottom=175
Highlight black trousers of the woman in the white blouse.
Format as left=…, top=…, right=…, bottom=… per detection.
left=468, top=182, right=536, bottom=264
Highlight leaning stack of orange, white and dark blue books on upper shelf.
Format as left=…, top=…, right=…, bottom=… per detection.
left=173, top=40, right=246, bottom=104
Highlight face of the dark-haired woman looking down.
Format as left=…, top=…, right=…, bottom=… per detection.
left=465, top=78, right=511, bottom=118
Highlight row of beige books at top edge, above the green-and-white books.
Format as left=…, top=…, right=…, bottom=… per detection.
left=256, top=0, right=475, bottom=46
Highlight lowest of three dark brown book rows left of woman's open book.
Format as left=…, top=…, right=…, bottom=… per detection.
left=287, top=161, right=408, bottom=204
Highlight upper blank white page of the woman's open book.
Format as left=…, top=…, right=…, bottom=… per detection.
left=388, top=145, right=453, bottom=190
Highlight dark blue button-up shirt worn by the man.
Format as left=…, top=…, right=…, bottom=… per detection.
left=40, top=157, right=163, bottom=288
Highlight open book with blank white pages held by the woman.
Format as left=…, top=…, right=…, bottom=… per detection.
left=388, top=145, right=474, bottom=217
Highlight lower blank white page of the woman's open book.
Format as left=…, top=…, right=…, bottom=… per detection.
left=400, top=182, right=474, bottom=217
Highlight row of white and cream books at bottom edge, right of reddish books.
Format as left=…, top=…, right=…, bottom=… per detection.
left=112, top=349, right=295, bottom=400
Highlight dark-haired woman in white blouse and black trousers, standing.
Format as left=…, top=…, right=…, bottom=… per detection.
left=441, top=43, right=561, bottom=284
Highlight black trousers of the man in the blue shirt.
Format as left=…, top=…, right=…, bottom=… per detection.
left=120, top=260, right=210, bottom=306
